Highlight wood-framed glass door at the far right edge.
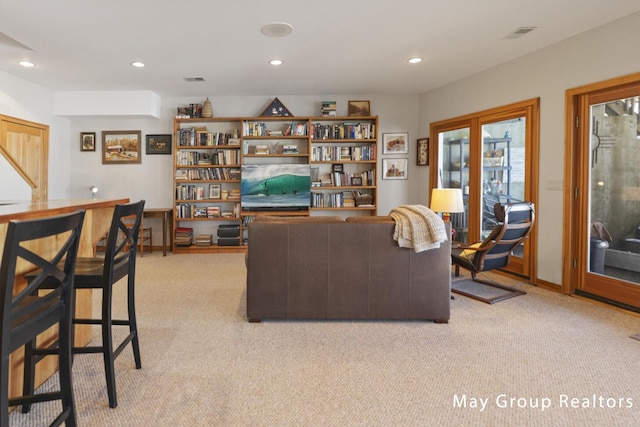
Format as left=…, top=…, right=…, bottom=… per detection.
left=564, top=75, right=640, bottom=309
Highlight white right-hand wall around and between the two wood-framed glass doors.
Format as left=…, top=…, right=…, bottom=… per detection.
left=419, top=13, right=640, bottom=284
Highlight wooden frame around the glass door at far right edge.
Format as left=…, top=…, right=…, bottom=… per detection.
left=562, top=73, right=640, bottom=294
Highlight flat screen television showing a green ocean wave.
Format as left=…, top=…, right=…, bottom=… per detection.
left=240, top=164, right=311, bottom=211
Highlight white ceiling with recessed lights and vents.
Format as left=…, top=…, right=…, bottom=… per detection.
left=0, top=0, right=640, bottom=96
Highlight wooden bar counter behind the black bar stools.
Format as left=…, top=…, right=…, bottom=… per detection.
left=0, top=199, right=129, bottom=396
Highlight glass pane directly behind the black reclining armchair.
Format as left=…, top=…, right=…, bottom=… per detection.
left=480, top=116, right=527, bottom=258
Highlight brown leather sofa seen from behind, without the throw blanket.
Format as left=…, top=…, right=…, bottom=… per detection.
left=246, top=217, right=451, bottom=323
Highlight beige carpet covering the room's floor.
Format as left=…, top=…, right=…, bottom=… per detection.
left=11, top=253, right=640, bottom=427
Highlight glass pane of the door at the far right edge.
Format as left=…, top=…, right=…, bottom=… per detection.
left=586, top=96, right=640, bottom=283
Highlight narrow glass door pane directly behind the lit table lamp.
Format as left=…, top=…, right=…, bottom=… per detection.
left=438, top=127, right=469, bottom=243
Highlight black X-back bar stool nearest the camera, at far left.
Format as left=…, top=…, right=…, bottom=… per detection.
left=0, top=211, right=84, bottom=427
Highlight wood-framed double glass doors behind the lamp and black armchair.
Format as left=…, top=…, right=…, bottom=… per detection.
left=429, top=99, right=539, bottom=281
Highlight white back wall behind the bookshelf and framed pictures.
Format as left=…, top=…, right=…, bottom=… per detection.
left=71, top=95, right=420, bottom=214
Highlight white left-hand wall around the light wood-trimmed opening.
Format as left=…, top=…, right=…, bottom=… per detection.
left=0, top=71, right=70, bottom=200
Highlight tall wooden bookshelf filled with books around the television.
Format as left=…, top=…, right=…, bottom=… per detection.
left=173, top=116, right=378, bottom=253
